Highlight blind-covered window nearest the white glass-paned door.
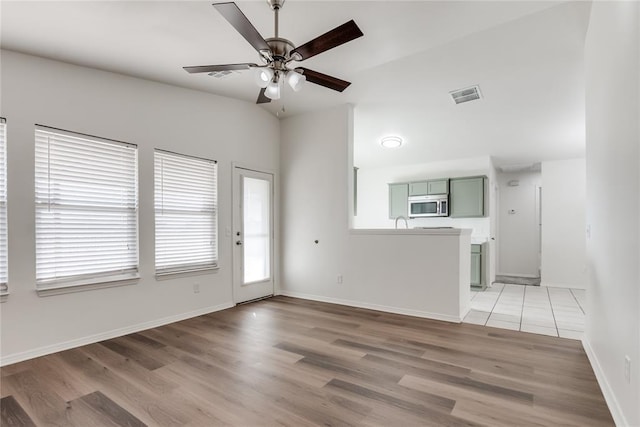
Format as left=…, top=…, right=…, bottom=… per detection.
left=154, top=150, right=218, bottom=275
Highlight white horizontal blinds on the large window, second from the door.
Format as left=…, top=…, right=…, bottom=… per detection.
left=35, top=126, right=138, bottom=289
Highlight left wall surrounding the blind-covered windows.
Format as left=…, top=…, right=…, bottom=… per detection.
left=0, top=51, right=279, bottom=363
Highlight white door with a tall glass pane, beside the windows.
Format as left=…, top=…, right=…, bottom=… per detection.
left=233, top=166, right=273, bottom=304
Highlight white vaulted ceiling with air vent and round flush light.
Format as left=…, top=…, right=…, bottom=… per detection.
left=0, top=0, right=590, bottom=171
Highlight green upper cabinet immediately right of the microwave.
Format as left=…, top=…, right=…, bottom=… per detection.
left=449, top=176, right=485, bottom=218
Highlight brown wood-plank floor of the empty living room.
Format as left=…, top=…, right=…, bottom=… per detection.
left=0, top=297, right=614, bottom=427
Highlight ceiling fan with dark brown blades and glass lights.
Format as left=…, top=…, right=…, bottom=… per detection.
left=184, top=0, right=363, bottom=104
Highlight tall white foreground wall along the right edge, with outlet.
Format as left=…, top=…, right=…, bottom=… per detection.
left=583, top=2, right=640, bottom=426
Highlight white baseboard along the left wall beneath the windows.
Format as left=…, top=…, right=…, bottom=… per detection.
left=0, top=302, right=235, bottom=366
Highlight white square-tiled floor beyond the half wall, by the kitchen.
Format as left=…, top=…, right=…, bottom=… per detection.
left=463, top=283, right=585, bottom=340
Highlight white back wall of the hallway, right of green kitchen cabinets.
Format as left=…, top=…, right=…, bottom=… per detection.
left=497, top=172, right=544, bottom=277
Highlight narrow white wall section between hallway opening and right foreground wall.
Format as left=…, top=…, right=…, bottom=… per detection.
left=541, top=159, right=587, bottom=289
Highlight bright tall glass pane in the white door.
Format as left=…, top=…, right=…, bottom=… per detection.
left=242, top=177, right=271, bottom=283
